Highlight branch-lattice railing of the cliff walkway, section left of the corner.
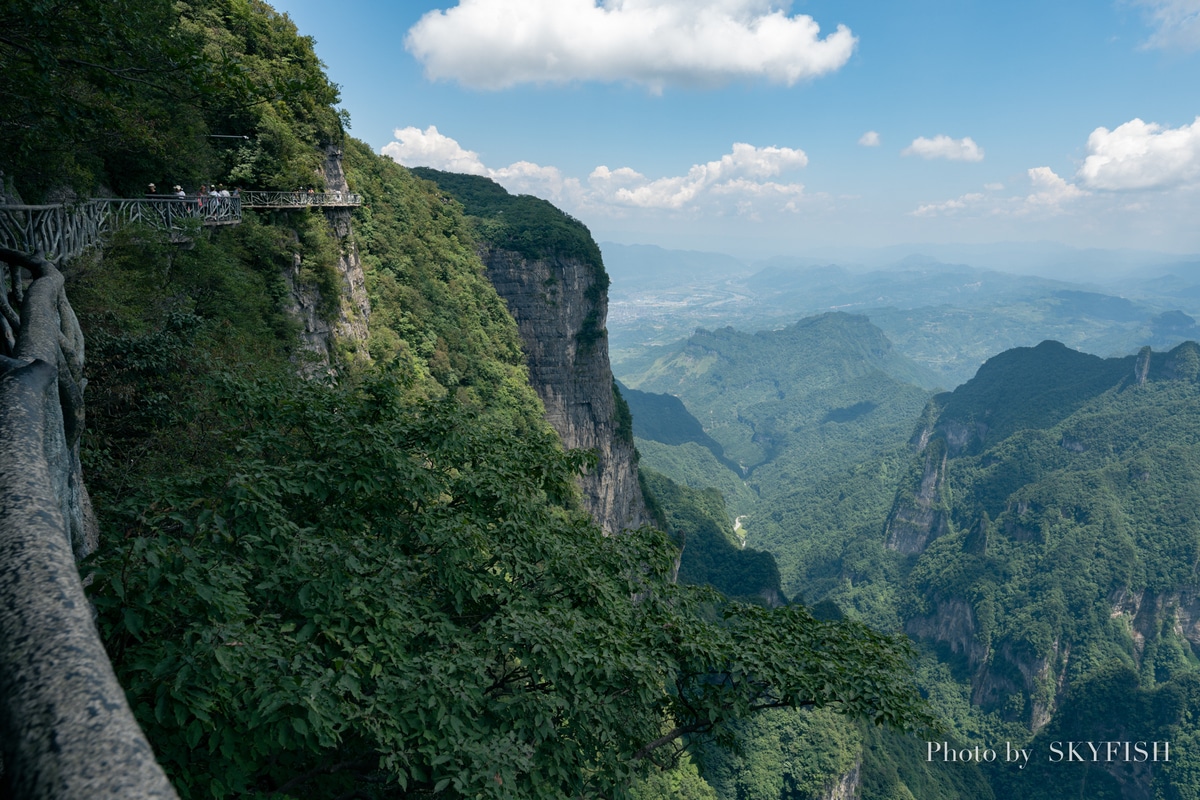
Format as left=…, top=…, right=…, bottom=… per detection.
left=0, top=194, right=241, bottom=261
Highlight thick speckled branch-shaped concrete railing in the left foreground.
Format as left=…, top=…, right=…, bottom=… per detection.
left=0, top=248, right=176, bottom=800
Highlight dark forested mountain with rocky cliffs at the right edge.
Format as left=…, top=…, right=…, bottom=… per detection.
left=886, top=342, right=1200, bottom=796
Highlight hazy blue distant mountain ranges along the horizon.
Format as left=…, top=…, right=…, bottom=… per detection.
left=605, top=245, right=1200, bottom=387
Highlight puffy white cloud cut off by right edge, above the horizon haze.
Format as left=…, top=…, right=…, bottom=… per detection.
left=1078, top=116, right=1200, bottom=191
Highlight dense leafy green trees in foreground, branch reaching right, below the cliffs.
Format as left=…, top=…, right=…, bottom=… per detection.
left=88, top=377, right=925, bottom=798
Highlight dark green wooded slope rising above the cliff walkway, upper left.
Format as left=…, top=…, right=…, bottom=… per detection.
left=0, top=0, right=343, bottom=200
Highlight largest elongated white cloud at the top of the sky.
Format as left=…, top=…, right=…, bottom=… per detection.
left=404, top=0, right=857, bottom=91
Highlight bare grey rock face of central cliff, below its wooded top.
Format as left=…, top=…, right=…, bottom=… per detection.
left=480, top=247, right=648, bottom=533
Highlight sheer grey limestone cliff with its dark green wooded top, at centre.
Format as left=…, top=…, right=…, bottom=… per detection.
left=403, top=167, right=649, bottom=533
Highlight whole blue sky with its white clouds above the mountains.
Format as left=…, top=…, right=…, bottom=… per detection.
left=274, top=0, right=1200, bottom=257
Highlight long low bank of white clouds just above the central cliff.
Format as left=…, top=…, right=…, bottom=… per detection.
left=382, top=126, right=809, bottom=213
